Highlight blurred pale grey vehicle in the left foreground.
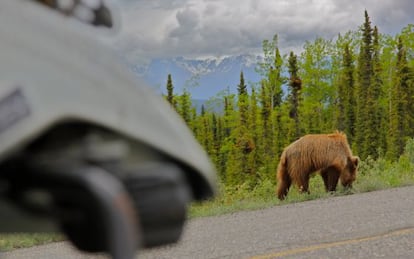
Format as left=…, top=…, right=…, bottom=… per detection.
left=0, top=0, right=216, bottom=258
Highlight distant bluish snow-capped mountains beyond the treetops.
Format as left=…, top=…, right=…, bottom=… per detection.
left=131, top=55, right=261, bottom=100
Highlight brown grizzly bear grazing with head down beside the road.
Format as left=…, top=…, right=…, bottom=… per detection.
left=277, top=131, right=359, bottom=200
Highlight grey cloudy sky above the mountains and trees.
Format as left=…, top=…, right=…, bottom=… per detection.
left=110, top=0, right=414, bottom=62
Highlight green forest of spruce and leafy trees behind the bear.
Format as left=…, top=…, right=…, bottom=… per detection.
left=165, top=11, right=414, bottom=200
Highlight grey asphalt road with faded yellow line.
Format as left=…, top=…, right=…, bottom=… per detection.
left=0, top=186, right=414, bottom=259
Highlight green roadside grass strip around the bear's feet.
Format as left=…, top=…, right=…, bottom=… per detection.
left=189, top=151, right=414, bottom=218
